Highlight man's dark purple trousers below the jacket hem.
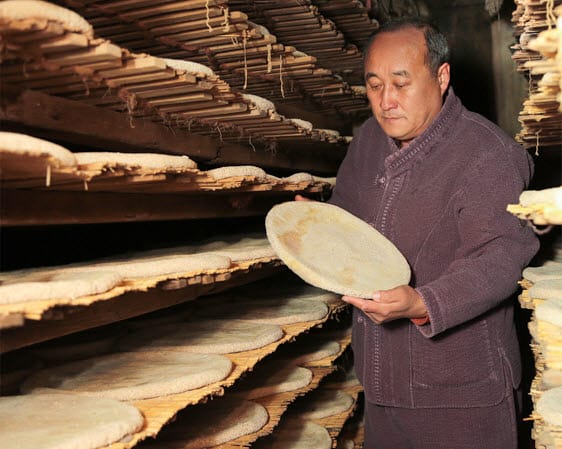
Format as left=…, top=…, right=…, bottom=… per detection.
left=363, top=386, right=520, bottom=449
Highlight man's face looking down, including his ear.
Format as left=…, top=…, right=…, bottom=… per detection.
left=365, top=28, right=449, bottom=146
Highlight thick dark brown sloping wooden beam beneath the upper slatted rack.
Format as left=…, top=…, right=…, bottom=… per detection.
left=0, top=86, right=346, bottom=175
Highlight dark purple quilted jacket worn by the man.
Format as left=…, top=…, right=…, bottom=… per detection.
left=330, top=89, right=539, bottom=407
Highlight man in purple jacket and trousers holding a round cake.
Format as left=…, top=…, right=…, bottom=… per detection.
left=308, top=19, right=538, bottom=449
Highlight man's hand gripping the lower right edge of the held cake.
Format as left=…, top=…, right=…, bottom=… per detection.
left=342, top=285, right=427, bottom=324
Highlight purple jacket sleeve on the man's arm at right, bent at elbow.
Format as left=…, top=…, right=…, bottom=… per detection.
left=416, top=147, right=539, bottom=337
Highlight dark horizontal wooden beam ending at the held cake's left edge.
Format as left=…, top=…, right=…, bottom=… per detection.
left=0, top=189, right=306, bottom=226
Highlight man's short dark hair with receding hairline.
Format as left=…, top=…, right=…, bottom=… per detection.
left=364, top=17, right=450, bottom=76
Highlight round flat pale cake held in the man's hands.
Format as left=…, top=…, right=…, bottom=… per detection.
left=265, top=201, right=411, bottom=298
